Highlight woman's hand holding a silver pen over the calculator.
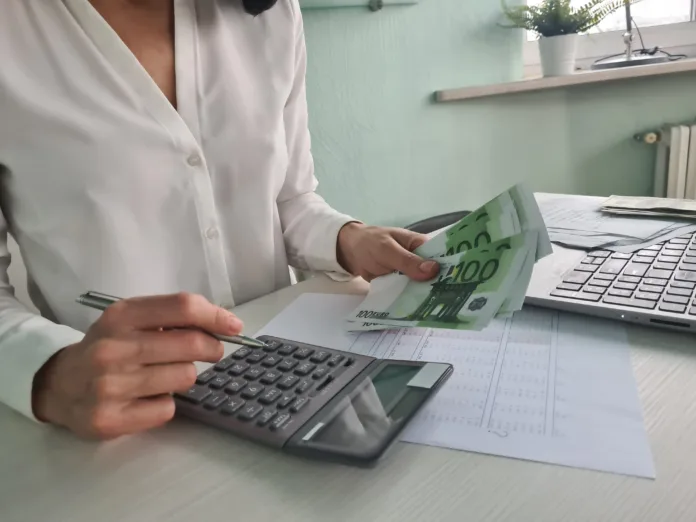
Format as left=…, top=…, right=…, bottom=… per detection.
left=32, top=293, right=243, bottom=439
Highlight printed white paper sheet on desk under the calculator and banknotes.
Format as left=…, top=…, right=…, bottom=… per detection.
left=258, top=294, right=655, bottom=478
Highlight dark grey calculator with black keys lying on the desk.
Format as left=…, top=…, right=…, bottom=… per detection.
left=174, top=336, right=453, bottom=467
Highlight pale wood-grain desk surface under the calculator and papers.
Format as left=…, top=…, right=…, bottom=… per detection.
left=0, top=276, right=696, bottom=522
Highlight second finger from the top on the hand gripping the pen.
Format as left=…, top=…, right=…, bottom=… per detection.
left=92, top=330, right=225, bottom=369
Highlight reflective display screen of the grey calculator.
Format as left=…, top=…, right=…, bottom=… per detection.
left=311, top=364, right=420, bottom=451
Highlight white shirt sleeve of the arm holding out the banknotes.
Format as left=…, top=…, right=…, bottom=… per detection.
left=278, top=0, right=356, bottom=279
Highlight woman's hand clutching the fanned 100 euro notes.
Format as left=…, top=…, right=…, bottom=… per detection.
left=337, top=223, right=439, bottom=281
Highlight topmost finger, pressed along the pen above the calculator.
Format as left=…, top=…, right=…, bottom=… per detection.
left=98, top=292, right=243, bottom=335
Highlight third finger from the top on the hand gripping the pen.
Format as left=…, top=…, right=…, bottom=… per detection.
left=96, top=363, right=196, bottom=401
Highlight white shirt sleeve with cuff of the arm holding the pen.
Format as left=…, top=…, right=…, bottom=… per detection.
left=0, top=207, right=84, bottom=420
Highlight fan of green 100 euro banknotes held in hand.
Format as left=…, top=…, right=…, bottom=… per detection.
left=346, top=184, right=553, bottom=331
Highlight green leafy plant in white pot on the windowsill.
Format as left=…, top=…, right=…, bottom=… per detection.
left=503, top=0, right=634, bottom=76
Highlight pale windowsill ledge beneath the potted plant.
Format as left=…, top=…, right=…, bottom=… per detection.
left=435, top=58, right=696, bottom=102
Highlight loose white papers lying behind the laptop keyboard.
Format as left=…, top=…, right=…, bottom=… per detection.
left=539, top=195, right=696, bottom=253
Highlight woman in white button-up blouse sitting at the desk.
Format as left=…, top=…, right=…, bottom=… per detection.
left=0, top=0, right=437, bottom=438
